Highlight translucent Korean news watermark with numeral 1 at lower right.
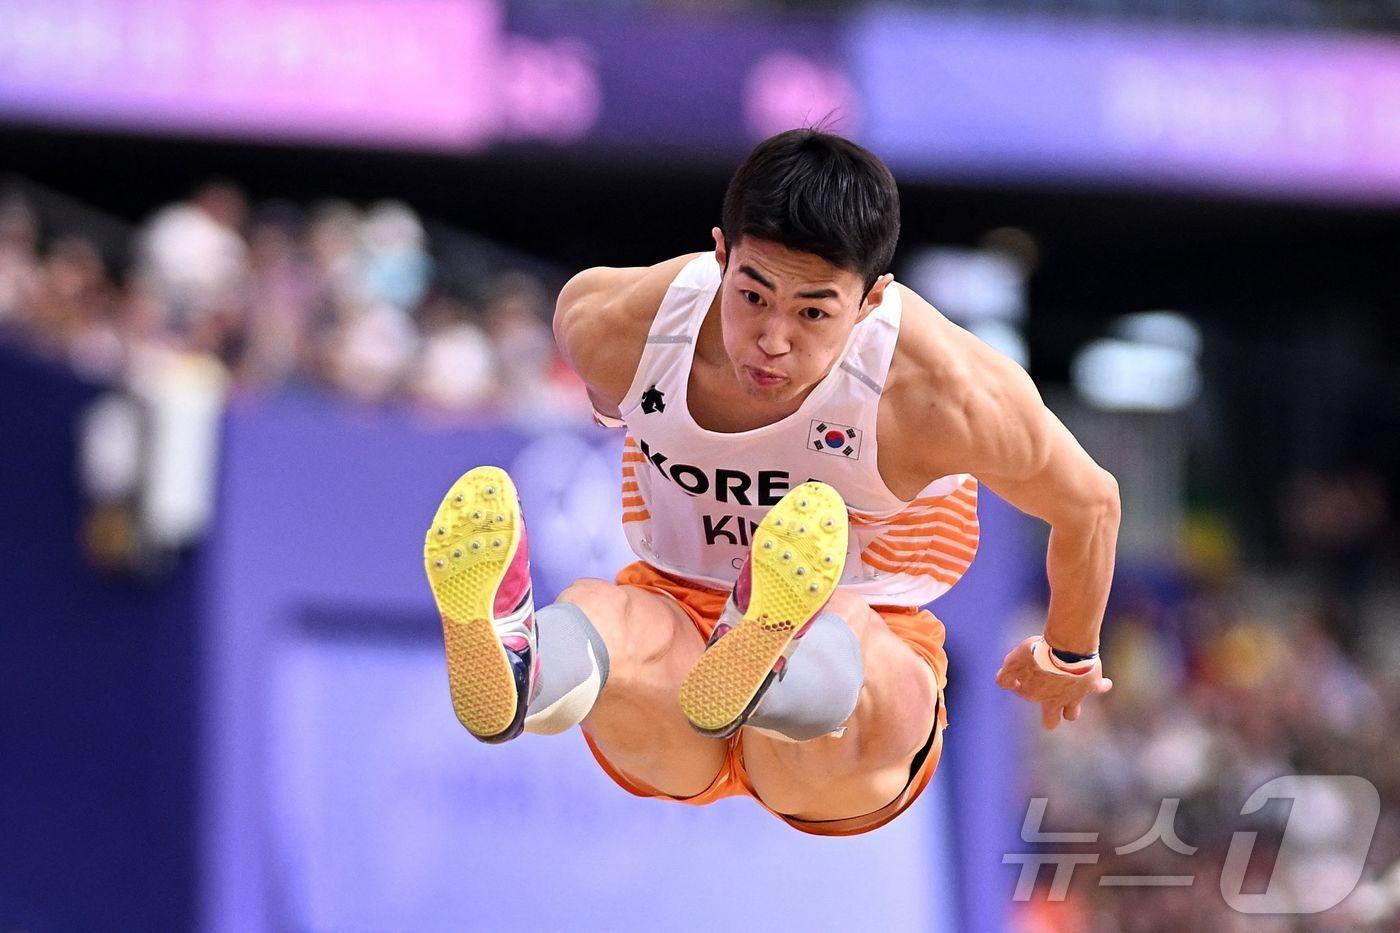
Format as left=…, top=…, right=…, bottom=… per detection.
left=1001, top=775, right=1380, bottom=915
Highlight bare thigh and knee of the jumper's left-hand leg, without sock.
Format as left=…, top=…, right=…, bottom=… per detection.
left=562, top=580, right=727, bottom=797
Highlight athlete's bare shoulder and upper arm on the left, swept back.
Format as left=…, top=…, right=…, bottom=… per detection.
left=554, top=254, right=699, bottom=416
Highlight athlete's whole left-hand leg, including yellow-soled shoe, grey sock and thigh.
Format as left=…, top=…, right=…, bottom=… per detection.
left=423, top=467, right=727, bottom=797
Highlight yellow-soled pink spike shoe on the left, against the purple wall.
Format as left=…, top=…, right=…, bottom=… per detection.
left=423, top=467, right=539, bottom=742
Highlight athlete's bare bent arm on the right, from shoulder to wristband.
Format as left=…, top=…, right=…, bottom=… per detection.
left=900, top=289, right=1120, bottom=654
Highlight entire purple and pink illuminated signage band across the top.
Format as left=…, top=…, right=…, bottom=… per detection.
left=0, top=0, right=1400, bottom=203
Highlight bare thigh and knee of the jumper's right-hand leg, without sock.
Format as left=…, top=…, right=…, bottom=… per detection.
left=743, top=590, right=938, bottom=821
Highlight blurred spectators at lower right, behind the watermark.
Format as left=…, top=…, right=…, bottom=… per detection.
left=1018, top=549, right=1400, bottom=933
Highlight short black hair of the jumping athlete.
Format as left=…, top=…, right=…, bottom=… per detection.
left=720, top=129, right=899, bottom=293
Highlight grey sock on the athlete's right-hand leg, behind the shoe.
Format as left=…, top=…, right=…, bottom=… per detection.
left=748, top=612, right=865, bottom=741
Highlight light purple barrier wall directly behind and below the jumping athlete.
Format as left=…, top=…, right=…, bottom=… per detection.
left=203, top=398, right=1015, bottom=933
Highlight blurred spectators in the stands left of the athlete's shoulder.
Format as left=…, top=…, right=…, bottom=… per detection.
left=0, top=184, right=588, bottom=420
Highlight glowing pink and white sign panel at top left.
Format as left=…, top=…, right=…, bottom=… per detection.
left=0, top=0, right=501, bottom=150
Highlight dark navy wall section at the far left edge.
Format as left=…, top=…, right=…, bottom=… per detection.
left=0, top=343, right=200, bottom=933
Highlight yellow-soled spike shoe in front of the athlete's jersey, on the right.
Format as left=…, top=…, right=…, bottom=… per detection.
left=680, top=482, right=847, bottom=738
